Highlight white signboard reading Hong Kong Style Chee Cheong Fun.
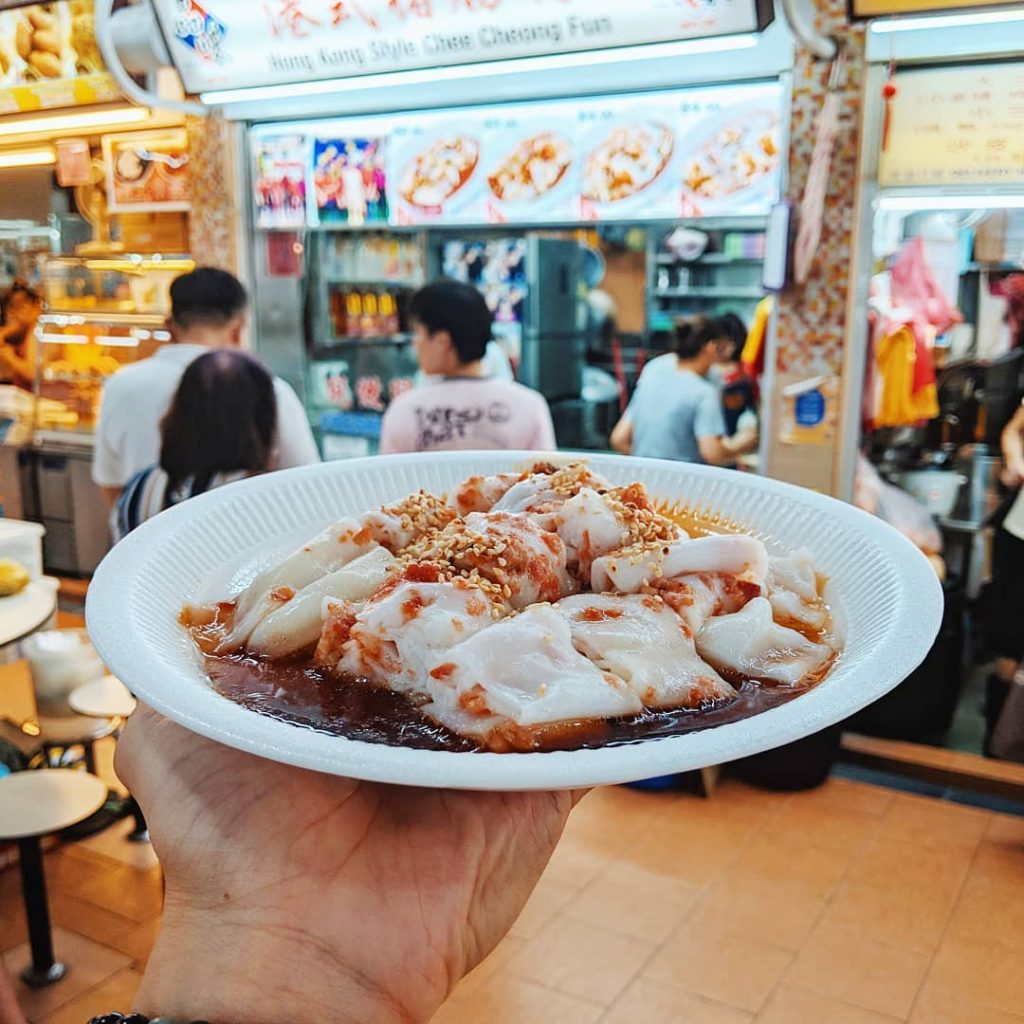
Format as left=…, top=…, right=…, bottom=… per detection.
left=154, top=0, right=772, bottom=92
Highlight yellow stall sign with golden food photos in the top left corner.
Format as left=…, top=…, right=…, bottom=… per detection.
left=0, top=0, right=120, bottom=115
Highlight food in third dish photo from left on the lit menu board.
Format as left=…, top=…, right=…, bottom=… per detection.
left=583, top=121, right=676, bottom=203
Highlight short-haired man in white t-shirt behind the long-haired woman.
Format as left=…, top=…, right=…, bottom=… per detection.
left=92, top=267, right=319, bottom=505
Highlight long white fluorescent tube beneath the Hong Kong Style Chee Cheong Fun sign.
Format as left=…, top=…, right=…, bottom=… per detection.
left=200, top=33, right=759, bottom=106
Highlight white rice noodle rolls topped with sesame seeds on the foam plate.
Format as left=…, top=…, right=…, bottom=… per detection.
left=182, top=463, right=837, bottom=752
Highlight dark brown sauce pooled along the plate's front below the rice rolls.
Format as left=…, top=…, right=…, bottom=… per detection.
left=206, top=654, right=805, bottom=752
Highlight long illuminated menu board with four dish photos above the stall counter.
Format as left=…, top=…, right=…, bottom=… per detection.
left=252, top=82, right=785, bottom=227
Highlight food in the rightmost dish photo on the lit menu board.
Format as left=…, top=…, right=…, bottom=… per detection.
left=684, top=111, right=779, bottom=199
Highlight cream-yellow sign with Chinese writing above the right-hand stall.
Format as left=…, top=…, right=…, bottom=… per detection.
left=879, top=62, right=1024, bottom=186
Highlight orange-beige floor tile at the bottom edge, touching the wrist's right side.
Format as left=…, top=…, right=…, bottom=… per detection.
left=431, top=972, right=604, bottom=1024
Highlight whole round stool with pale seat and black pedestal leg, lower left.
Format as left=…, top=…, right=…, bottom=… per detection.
left=0, top=768, right=106, bottom=988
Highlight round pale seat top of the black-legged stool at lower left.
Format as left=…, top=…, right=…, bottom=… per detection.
left=0, top=768, right=106, bottom=840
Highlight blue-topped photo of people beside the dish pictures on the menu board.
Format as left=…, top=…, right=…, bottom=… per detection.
left=313, top=138, right=389, bottom=226
